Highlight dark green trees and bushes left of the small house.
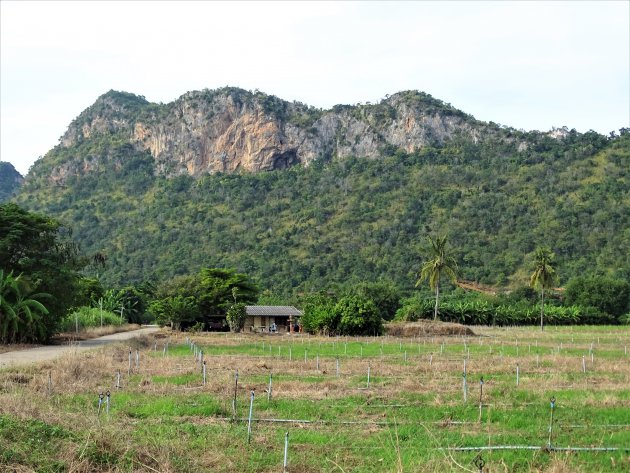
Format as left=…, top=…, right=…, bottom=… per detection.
left=0, top=203, right=266, bottom=344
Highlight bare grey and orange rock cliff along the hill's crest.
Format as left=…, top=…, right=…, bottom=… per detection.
left=44, top=88, right=498, bottom=182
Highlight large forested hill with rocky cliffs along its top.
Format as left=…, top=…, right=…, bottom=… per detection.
left=16, top=88, right=630, bottom=294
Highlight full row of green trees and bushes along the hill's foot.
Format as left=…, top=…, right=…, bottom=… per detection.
left=0, top=204, right=630, bottom=343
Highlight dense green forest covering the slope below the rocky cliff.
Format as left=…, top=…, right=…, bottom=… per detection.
left=17, top=130, right=630, bottom=294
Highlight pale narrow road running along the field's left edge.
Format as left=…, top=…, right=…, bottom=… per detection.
left=0, top=327, right=160, bottom=369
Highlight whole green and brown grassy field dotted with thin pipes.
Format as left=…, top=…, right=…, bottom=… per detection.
left=0, top=327, right=630, bottom=472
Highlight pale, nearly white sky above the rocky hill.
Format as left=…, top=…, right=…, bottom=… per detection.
left=0, top=0, right=630, bottom=174
